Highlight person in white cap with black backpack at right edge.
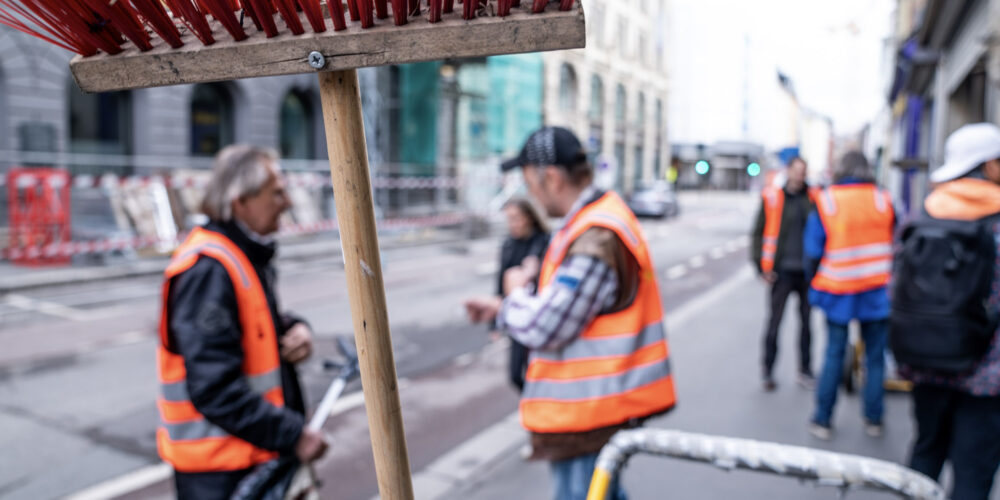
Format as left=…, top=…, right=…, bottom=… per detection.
left=892, top=123, right=1000, bottom=500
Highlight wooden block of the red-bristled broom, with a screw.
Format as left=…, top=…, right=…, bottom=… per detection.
left=70, top=7, right=586, bottom=92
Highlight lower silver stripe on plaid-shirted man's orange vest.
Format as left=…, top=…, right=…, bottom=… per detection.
left=524, top=360, right=670, bottom=402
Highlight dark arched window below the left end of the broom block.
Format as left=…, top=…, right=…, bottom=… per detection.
left=68, top=78, right=132, bottom=155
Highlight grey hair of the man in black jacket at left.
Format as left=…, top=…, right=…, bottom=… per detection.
left=201, top=144, right=279, bottom=222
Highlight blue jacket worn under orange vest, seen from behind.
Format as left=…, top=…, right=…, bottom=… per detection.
left=803, top=178, right=889, bottom=325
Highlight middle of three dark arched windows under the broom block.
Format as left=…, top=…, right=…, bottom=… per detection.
left=191, top=83, right=235, bottom=156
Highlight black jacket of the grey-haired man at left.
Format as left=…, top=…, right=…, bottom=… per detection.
left=167, top=223, right=305, bottom=453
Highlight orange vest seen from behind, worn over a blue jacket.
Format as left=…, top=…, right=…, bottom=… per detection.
left=812, top=184, right=895, bottom=295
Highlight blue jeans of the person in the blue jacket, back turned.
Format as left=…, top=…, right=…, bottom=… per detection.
left=813, top=320, right=889, bottom=426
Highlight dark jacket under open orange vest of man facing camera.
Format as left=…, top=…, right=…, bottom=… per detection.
left=750, top=186, right=814, bottom=273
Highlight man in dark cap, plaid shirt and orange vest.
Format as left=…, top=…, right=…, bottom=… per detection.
left=466, top=127, right=676, bottom=500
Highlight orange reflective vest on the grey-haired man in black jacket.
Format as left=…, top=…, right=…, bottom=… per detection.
left=156, top=228, right=285, bottom=472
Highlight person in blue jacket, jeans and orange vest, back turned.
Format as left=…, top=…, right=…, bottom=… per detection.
left=804, top=151, right=895, bottom=440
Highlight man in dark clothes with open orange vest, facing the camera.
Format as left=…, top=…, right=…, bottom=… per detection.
left=751, top=157, right=816, bottom=391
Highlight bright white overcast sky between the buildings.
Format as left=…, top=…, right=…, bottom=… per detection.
left=669, top=0, right=894, bottom=139
